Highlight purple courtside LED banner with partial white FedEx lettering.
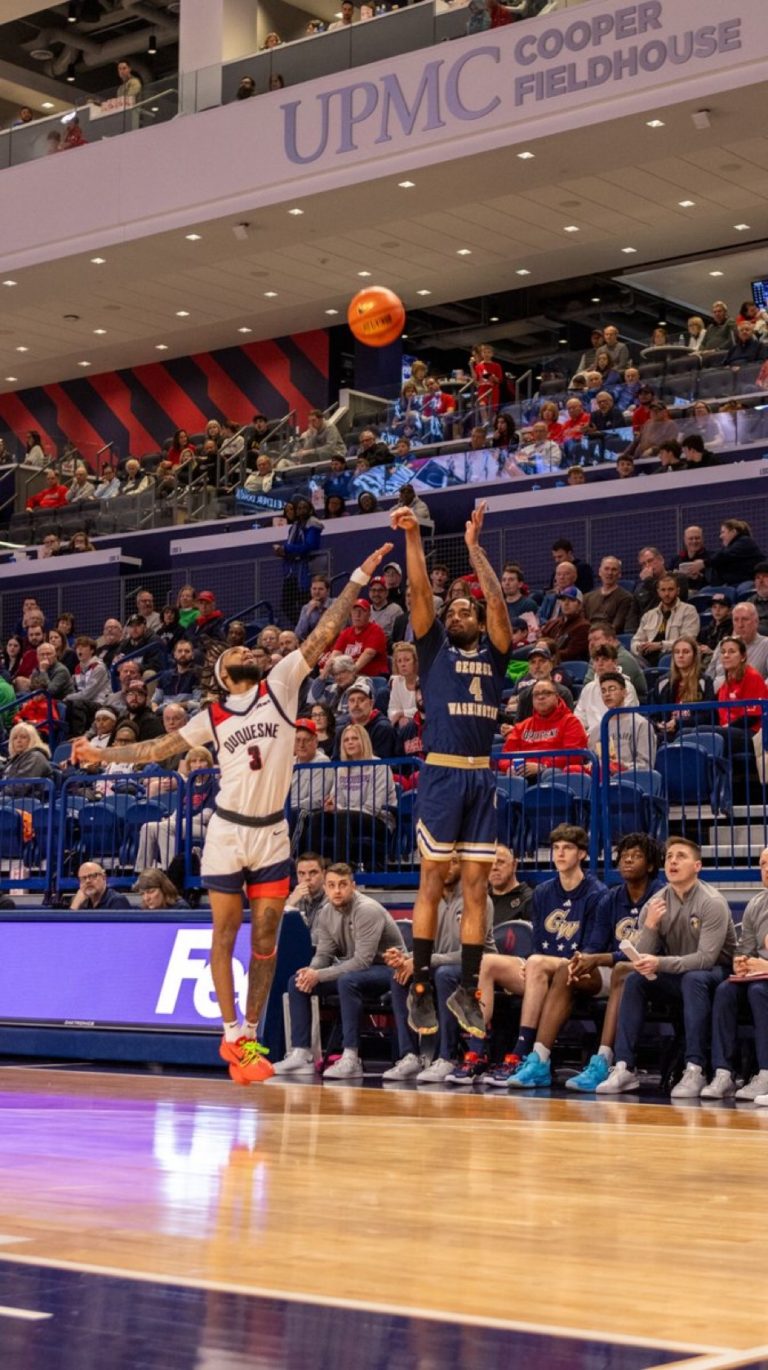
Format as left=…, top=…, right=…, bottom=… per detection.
left=0, top=917, right=251, bottom=1033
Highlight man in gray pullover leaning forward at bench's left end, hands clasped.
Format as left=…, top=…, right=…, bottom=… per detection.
left=275, top=862, right=405, bottom=1080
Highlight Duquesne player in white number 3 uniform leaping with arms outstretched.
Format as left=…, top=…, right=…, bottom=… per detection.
left=71, top=543, right=392, bottom=1085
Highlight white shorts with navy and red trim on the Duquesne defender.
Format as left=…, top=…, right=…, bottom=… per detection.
left=200, top=814, right=290, bottom=899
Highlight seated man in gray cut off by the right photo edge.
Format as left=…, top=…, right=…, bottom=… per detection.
left=701, top=847, right=768, bottom=1104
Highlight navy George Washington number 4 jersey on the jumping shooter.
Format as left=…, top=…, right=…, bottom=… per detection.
left=416, top=619, right=509, bottom=756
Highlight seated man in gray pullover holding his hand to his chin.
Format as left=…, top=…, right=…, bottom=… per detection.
left=597, top=837, right=737, bottom=1099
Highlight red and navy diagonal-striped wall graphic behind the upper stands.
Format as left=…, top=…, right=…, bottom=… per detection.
left=0, top=329, right=329, bottom=458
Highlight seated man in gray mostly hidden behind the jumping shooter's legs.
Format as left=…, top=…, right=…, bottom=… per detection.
left=382, top=855, right=496, bottom=1085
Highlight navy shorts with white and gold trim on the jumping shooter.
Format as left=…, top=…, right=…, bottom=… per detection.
left=416, top=764, right=497, bottom=862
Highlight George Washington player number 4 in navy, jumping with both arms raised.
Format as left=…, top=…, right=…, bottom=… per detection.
left=392, top=503, right=512, bottom=1037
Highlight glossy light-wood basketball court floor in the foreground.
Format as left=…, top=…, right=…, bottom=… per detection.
left=0, top=1067, right=768, bottom=1370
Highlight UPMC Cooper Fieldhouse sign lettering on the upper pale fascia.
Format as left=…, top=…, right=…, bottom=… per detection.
left=281, top=0, right=744, bottom=169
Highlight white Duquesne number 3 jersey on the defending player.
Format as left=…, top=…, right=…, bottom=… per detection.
left=179, top=651, right=309, bottom=818
